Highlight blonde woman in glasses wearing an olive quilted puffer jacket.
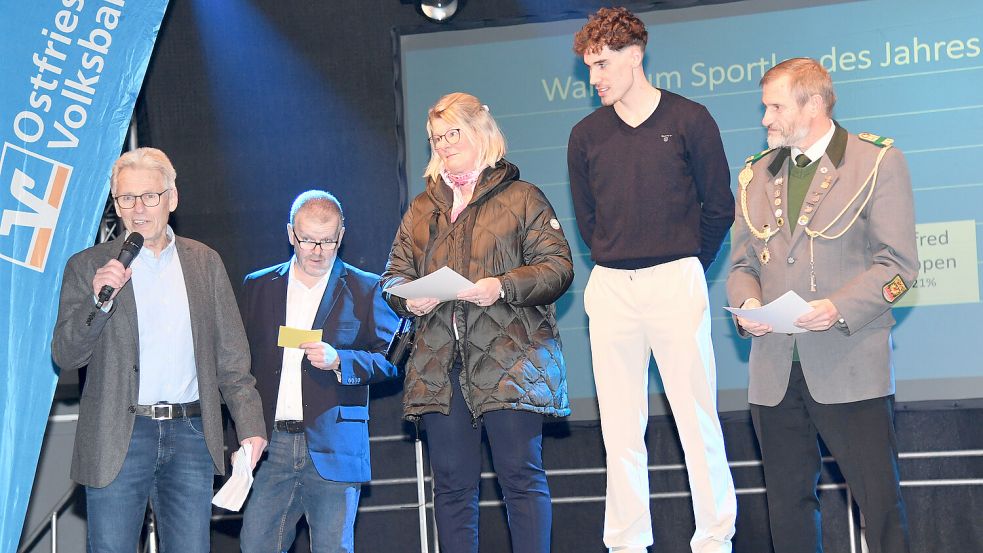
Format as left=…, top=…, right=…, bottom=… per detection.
left=383, top=93, right=573, bottom=553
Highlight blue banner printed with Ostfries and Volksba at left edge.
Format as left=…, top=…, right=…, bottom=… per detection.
left=0, top=0, right=167, bottom=552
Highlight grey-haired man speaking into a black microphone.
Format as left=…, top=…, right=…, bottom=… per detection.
left=51, top=148, right=266, bottom=553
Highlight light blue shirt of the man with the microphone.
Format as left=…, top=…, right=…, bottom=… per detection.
left=130, top=225, right=198, bottom=405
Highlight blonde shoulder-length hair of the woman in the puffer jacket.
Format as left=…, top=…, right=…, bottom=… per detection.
left=423, top=92, right=505, bottom=180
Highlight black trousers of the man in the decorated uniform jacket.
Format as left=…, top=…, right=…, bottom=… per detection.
left=751, top=362, right=909, bottom=553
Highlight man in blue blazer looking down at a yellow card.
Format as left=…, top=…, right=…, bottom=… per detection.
left=241, top=190, right=398, bottom=553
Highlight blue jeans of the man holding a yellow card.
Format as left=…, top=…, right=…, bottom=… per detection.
left=239, top=431, right=361, bottom=553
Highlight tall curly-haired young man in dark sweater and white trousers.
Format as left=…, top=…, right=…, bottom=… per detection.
left=567, top=8, right=737, bottom=553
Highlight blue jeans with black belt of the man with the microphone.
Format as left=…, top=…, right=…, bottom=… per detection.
left=85, top=417, right=215, bottom=553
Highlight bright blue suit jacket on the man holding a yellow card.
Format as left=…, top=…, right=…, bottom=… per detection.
left=241, top=259, right=399, bottom=482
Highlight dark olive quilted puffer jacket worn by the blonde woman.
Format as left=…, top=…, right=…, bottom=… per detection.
left=383, top=160, right=573, bottom=418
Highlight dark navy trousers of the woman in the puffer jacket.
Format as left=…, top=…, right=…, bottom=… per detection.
left=423, top=366, right=553, bottom=553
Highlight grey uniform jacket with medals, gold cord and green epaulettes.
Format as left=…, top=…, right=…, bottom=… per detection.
left=727, top=126, right=919, bottom=406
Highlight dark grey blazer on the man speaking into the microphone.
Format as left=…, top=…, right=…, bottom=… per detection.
left=51, top=237, right=266, bottom=487
